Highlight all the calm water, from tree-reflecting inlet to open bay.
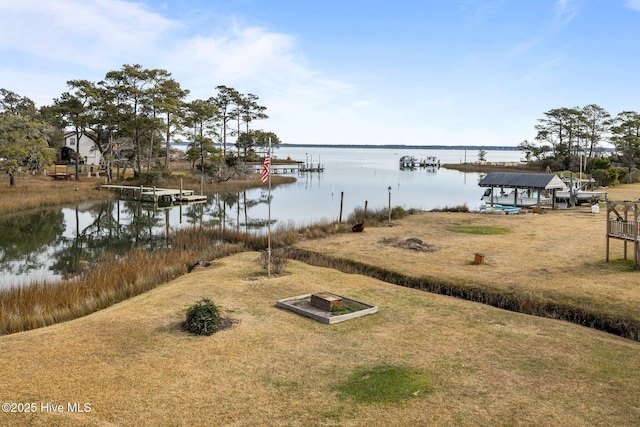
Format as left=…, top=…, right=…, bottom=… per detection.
left=0, top=147, right=521, bottom=288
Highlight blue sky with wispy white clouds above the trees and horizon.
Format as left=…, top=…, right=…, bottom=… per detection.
left=0, top=0, right=640, bottom=146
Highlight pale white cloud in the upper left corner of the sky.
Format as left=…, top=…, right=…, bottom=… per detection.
left=0, top=0, right=178, bottom=67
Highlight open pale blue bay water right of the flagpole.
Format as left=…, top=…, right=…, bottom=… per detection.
left=264, top=147, right=521, bottom=223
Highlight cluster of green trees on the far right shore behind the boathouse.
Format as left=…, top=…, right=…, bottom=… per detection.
left=518, top=104, right=640, bottom=185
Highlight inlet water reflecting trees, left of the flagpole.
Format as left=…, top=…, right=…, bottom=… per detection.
left=0, top=191, right=268, bottom=288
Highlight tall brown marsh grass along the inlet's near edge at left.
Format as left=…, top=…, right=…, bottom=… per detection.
left=0, top=230, right=247, bottom=334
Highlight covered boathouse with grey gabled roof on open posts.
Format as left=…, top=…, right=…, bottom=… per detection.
left=478, top=172, right=565, bottom=208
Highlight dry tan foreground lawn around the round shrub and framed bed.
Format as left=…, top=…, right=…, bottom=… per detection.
left=0, top=253, right=640, bottom=426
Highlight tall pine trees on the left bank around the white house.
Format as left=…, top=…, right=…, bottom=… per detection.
left=0, top=64, right=280, bottom=184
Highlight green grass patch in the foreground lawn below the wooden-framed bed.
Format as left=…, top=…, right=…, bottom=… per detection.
left=339, top=365, right=432, bottom=403
